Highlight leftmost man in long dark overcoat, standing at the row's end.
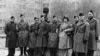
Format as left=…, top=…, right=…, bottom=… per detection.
left=5, top=16, right=17, bottom=56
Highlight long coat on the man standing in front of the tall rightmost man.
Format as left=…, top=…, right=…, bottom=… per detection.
left=73, top=22, right=89, bottom=53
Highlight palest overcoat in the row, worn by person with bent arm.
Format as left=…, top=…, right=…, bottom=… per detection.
left=58, top=22, right=73, bottom=49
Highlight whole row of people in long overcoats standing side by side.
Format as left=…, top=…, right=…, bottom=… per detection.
left=5, top=10, right=99, bottom=56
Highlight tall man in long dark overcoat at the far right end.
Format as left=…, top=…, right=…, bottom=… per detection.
left=88, top=10, right=99, bottom=56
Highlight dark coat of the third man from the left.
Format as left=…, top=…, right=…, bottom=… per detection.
left=28, top=23, right=39, bottom=48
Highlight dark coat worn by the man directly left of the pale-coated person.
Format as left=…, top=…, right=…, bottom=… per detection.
left=48, top=23, right=58, bottom=48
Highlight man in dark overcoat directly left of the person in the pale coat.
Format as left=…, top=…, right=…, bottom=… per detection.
left=48, top=16, right=59, bottom=56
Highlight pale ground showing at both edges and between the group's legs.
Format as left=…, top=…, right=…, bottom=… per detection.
left=0, top=38, right=100, bottom=56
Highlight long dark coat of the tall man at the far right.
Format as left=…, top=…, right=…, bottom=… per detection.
left=88, top=19, right=99, bottom=50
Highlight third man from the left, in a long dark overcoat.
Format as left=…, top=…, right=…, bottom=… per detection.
left=28, top=17, right=39, bottom=56
